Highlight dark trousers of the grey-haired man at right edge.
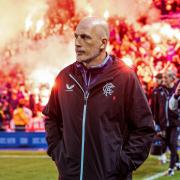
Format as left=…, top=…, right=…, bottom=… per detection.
left=166, top=127, right=179, bottom=168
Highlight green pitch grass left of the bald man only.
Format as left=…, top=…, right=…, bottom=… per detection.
left=0, top=151, right=57, bottom=180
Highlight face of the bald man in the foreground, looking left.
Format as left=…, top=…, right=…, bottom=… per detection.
left=75, top=24, right=101, bottom=63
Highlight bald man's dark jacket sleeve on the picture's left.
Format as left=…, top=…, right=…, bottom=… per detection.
left=42, top=78, right=62, bottom=158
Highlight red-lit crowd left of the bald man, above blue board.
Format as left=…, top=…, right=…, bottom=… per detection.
left=0, top=65, right=44, bottom=131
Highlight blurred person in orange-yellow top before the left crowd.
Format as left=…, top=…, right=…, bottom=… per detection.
left=13, top=99, right=30, bottom=131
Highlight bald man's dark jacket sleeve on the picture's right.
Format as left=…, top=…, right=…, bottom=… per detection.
left=122, top=72, right=155, bottom=170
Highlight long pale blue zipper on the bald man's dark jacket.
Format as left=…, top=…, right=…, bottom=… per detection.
left=69, top=74, right=89, bottom=180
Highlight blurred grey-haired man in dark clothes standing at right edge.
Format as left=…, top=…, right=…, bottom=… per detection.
left=163, top=69, right=180, bottom=176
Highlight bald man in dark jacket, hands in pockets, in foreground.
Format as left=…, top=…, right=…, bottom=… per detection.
left=43, top=17, right=154, bottom=180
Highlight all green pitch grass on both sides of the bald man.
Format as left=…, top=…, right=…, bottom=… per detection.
left=0, top=151, right=180, bottom=180
